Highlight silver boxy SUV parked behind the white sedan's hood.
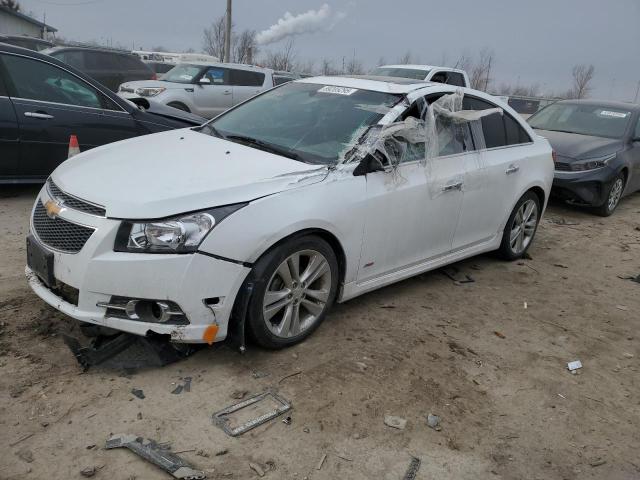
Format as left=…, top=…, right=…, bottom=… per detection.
left=118, top=63, right=286, bottom=118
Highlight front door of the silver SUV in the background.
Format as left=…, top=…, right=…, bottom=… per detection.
left=193, top=67, right=233, bottom=118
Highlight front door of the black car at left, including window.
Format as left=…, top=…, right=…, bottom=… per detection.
left=0, top=54, right=140, bottom=178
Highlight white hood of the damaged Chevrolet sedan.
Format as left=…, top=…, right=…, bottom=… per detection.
left=52, top=129, right=328, bottom=219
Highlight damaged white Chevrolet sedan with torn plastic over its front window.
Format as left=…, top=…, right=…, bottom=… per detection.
left=26, top=77, right=553, bottom=348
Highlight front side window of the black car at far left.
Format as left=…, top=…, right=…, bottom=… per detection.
left=4, top=55, right=102, bottom=108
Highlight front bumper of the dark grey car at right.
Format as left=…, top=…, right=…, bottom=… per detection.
left=551, top=167, right=617, bottom=207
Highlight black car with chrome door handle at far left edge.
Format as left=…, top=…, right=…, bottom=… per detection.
left=0, top=44, right=205, bottom=183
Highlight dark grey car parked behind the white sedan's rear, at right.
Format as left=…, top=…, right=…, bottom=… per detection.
left=527, top=100, right=640, bottom=217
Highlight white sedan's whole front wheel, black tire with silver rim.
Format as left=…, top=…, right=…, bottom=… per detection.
left=247, top=235, right=339, bottom=349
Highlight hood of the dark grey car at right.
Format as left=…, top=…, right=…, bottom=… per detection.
left=535, top=129, right=623, bottom=160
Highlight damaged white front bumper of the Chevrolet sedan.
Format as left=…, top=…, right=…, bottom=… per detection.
left=25, top=186, right=250, bottom=343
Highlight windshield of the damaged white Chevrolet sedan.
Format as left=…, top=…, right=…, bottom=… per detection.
left=199, top=83, right=402, bottom=165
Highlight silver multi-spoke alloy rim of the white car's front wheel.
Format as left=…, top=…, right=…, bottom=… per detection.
left=262, top=250, right=332, bottom=338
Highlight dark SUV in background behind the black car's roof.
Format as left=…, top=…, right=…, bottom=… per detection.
left=42, top=47, right=156, bottom=92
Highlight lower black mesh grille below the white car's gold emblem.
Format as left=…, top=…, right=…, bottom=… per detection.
left=33, top=200, right=93, bottom=253
